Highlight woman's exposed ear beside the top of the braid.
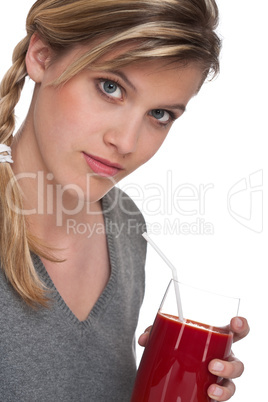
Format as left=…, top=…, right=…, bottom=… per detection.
left=25, top=33, right=52, bottom=83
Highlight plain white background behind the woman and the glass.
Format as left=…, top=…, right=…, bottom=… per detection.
left=0, top=0, right=268, bottom=402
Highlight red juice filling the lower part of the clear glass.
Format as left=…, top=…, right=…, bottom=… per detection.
left=131, top=313, right=232, bottom=402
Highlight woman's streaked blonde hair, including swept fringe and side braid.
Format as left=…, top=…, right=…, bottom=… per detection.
left=0, top=0, right=220, bottom=306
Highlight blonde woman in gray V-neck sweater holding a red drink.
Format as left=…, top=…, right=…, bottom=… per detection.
left=0, top=0, right=248, bottom=402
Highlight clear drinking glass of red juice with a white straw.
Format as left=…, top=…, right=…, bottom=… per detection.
left=131, top=280, right=239, bottom=402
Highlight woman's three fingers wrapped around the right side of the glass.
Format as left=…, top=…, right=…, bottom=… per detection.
left=208, top=317, right=249, bottom=401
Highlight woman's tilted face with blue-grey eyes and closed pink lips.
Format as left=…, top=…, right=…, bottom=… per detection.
left=17, top=42, right=203, bottom=201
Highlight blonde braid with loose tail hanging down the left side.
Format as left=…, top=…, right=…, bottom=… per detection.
left=0, top=37, right=49, bottom=305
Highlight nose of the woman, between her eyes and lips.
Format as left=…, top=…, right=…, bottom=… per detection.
left=104, top=114, right=142, bottom=155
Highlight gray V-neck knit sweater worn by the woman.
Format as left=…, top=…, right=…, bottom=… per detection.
left=0, top=189, right=146, bottom=402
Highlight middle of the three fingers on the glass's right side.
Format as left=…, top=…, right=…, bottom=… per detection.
left=208, top=355, right=244, bottom=379
